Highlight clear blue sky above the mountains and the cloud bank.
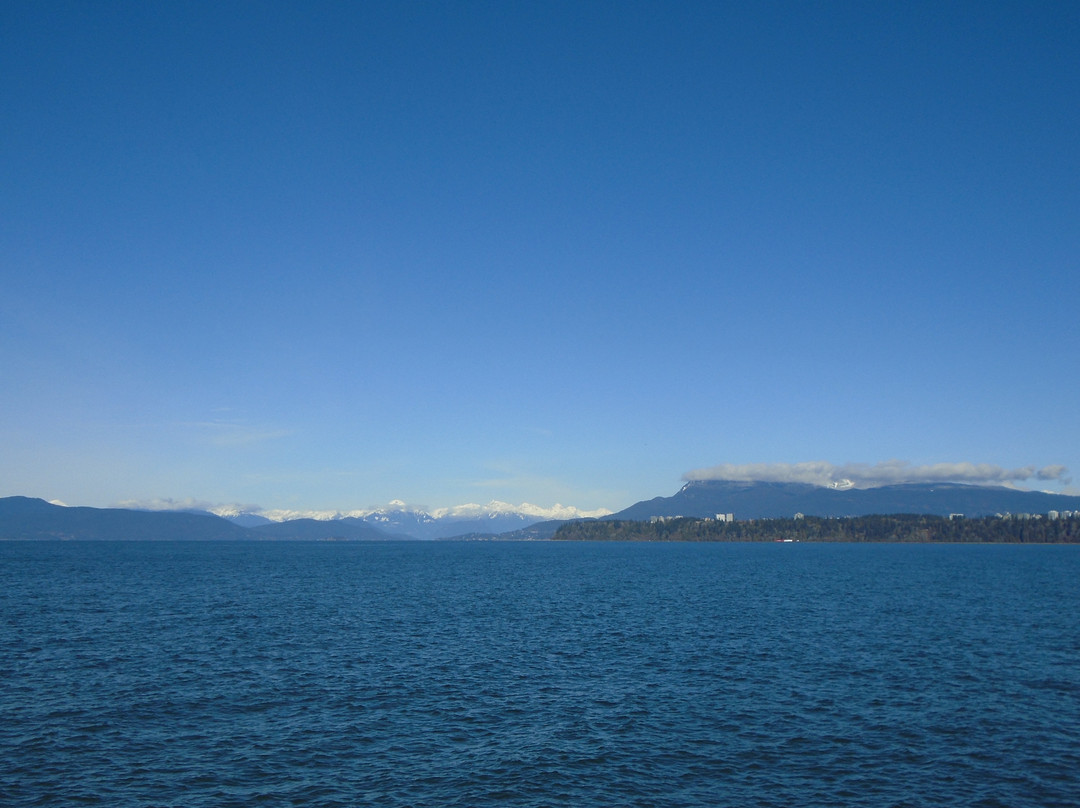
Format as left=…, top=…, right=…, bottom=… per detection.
left=0, top=0, right=1080, bottom=510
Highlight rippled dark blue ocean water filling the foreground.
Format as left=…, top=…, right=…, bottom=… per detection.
left=0, top=535, right=1080, bottom=808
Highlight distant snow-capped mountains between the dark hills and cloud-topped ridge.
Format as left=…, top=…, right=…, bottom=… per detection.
left=208, top=499, right=611, bottom=539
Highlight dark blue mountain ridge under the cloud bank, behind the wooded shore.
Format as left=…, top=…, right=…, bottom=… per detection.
left=603, top=481, right=1080, bottom=520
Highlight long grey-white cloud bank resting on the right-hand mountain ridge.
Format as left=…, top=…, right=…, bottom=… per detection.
left=683, top=460, right=1071, bottom=488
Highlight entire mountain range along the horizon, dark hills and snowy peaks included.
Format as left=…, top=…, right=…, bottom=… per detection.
left=0, top=481, right=1080, bottom=541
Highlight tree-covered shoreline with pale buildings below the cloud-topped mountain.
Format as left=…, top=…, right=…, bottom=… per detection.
left=552, top=514, right=1080, bottom=544
